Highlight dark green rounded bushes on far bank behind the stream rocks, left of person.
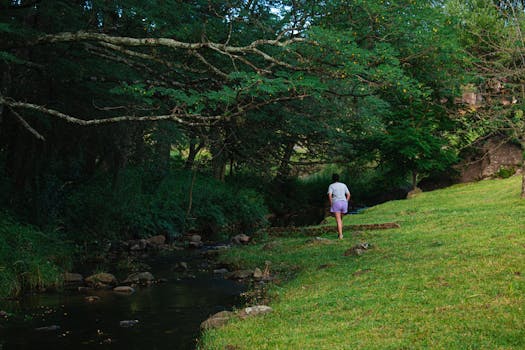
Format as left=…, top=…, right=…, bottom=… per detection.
left=64, top=167, right=266, bottom=241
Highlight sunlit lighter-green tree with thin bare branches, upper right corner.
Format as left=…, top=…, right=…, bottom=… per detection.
left=448, top=0, right=525, bottom=198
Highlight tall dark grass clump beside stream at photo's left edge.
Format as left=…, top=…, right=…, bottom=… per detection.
left=0, top=212, right=74, bottom=298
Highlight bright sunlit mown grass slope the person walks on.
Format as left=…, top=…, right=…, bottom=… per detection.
left=200, top=177, right=525, bottom=349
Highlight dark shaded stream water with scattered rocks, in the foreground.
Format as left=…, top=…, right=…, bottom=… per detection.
left=0, top=252, right=244, bottom=350
